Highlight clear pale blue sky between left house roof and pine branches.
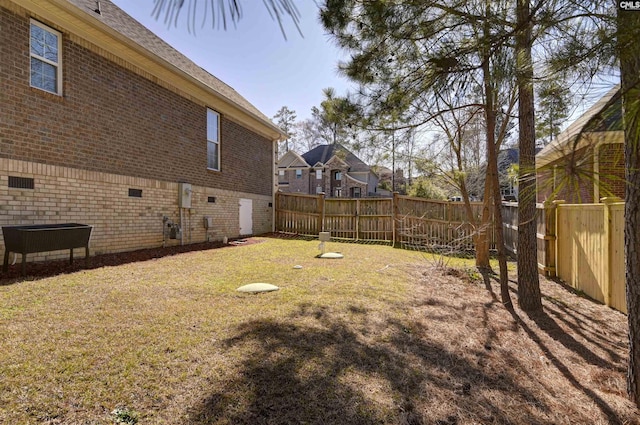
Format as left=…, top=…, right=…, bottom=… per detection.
left=107, top=0, right=351, bottom=120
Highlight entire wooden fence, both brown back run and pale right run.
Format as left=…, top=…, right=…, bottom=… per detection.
left=276, top=193, right=627, bottom=312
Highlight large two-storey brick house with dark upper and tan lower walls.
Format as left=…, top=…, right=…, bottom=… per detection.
left=0, top=0, right=284, bottom=259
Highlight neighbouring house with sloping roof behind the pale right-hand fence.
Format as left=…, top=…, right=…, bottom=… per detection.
left=536, top=86, right=625, bottom=203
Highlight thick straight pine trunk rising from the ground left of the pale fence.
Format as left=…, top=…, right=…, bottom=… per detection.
left=516, top=0, right=542, bottom=312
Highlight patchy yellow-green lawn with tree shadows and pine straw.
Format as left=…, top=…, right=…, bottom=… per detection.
left=0, top=238, right=639, bottom=425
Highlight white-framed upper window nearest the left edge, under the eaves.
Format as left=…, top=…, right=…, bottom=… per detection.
left=30, top=20, right=62, bottom=94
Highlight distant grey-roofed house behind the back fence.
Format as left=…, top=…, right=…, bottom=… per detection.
left=278, top=144, right=378, bottom=198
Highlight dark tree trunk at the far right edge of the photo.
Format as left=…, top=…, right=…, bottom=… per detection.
left=618, top=5, right=640, bottom=407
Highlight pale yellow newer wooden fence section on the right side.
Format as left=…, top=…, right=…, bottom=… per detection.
left=503, top=198, right=627, bottom=313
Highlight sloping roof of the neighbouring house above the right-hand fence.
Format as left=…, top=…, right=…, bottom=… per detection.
left=536, top=85, right=622, bottom=167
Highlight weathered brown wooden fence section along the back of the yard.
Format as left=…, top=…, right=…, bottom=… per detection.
left=276, top=192, right=494, bottom=249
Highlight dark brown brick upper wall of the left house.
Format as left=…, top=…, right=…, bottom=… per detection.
left=0, top=4, right=273, bottom=195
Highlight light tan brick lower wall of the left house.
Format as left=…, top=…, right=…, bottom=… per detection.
left=0, top=158, right=273, bottom=260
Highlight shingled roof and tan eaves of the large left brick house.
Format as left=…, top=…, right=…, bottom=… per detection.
left=20, top=0, right=286, bottom=140
